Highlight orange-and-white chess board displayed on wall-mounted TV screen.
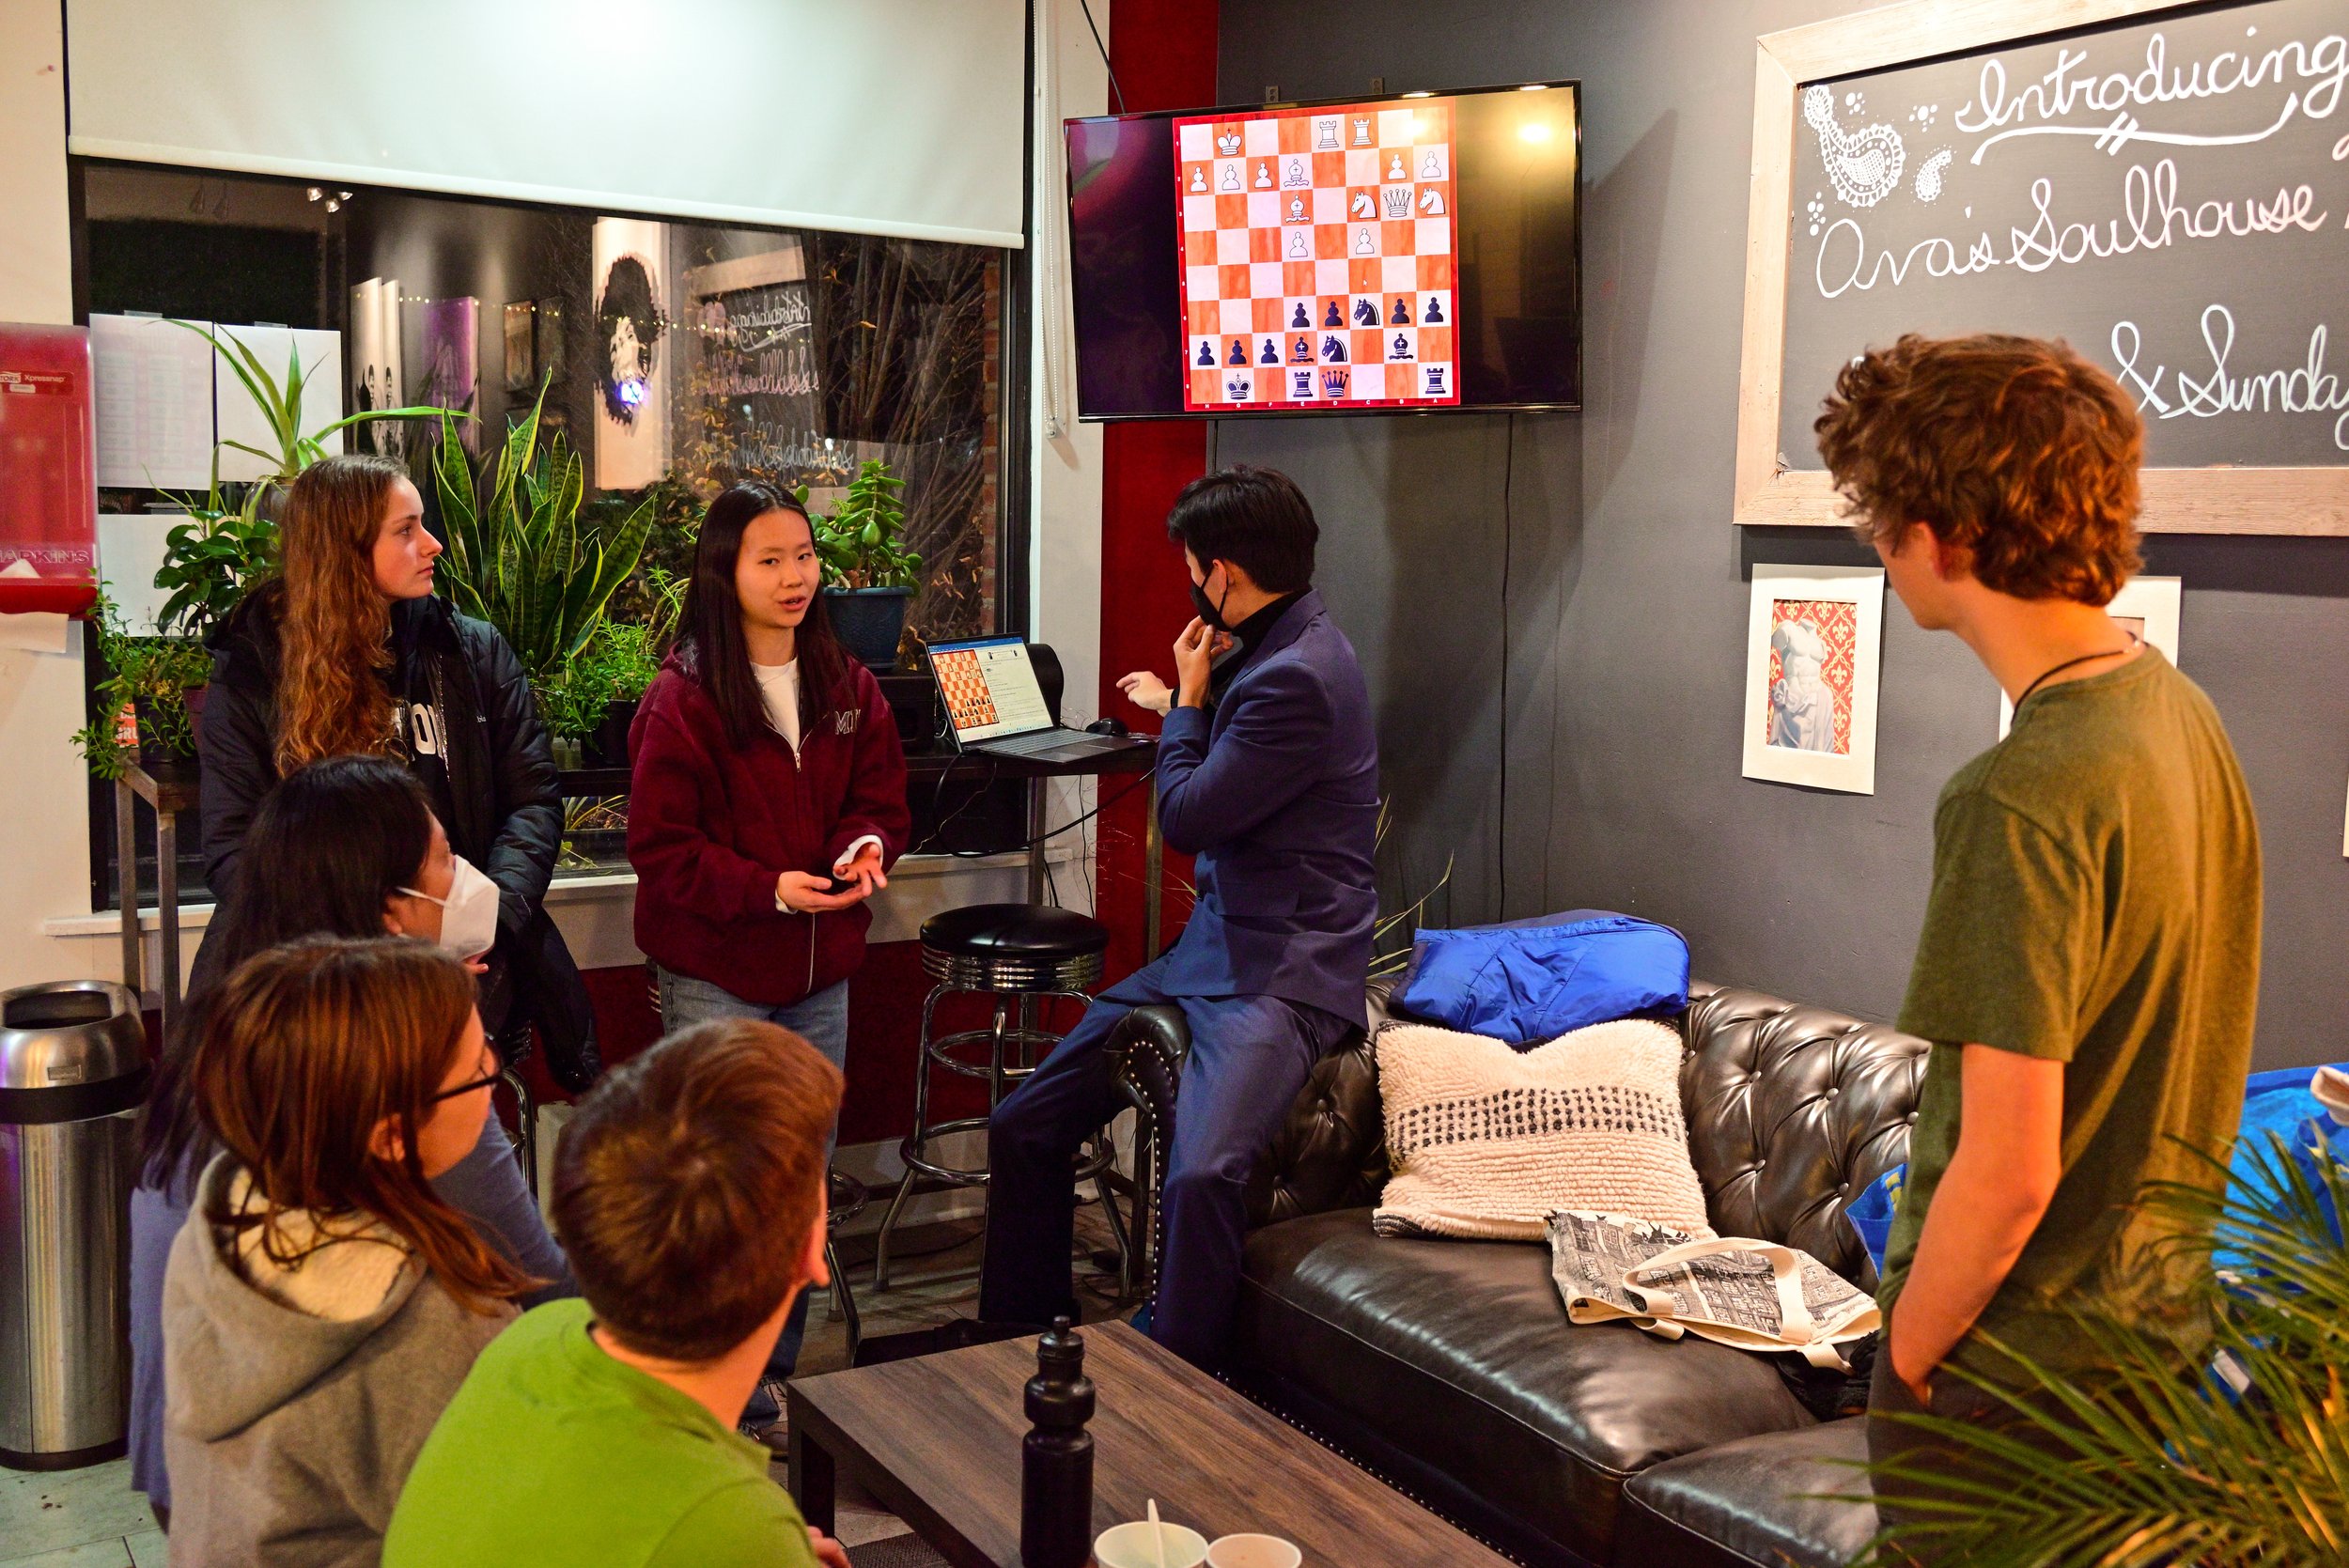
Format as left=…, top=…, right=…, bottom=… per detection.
left=1174, top=99, right=1461, bottom=413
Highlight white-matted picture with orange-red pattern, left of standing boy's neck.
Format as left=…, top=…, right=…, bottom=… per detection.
left=1743, top=566, right=1884, bottom=796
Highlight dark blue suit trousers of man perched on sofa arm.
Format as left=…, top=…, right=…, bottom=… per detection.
left=980, top=957, right=1361, bottom=1371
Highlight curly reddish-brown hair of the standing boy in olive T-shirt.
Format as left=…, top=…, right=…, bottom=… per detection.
left=1812, top=334, right=2145, bottom=606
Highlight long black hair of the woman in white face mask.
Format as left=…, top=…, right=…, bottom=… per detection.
left=139, top=756, right=432, bottom=1188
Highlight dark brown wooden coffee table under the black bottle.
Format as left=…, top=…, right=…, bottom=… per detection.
left=789, top=1324, right=1508, bottom=1568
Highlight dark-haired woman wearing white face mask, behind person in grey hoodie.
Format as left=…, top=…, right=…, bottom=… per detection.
left=130, top=756, right=573, bottom=1516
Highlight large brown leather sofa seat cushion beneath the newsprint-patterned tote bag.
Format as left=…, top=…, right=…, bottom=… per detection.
left=1234, top=1209, right=1813, bottom=1561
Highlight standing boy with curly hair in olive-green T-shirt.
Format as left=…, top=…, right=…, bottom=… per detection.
left=1818, top=335, right=2260, bottom=1519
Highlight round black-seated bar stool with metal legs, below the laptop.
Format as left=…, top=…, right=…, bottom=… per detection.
left=874, top=904, right=1130, bottom=1291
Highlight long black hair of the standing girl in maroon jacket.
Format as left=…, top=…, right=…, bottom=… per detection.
left=679, top=479, right=850, bottom=749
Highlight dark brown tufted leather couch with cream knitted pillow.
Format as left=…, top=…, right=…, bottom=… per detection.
left=1113, top=984, right=1926, bottom=1568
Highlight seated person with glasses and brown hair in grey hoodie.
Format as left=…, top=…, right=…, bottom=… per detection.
left=163, top=937, right=536, bottom=1568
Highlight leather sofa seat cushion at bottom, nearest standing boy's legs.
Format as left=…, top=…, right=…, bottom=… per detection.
left=1614, top=1416, right=1877, bottom=1568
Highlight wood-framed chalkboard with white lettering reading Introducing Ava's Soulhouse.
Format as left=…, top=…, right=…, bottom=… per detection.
left=1738, top=0, right=2349, bottom=533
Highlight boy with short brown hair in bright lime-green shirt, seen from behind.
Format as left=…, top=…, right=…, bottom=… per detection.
left=383, top=1018, right=848, bottom=1568
